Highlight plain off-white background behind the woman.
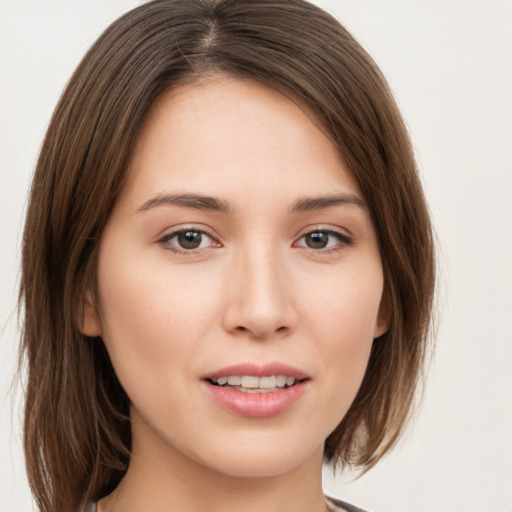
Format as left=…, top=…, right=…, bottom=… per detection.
left=0, top=0, right=512, bottom=512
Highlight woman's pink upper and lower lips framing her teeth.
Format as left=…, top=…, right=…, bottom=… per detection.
left=201, top=362, right=310, bottom=418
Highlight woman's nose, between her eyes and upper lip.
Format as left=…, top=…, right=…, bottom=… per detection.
left=223, top=244, right=297, bottom=340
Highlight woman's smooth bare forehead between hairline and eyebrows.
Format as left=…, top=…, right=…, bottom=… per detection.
left=121, top=78, right=360, bottom=209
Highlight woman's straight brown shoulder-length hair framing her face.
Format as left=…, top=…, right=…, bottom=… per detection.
left=20, top=0, right=435, bottom=512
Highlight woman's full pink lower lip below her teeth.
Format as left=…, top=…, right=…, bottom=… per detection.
left=203, top=381, right=308, bottom=418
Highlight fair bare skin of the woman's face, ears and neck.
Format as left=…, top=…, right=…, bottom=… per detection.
left=82, top=77, right=386, bottom=512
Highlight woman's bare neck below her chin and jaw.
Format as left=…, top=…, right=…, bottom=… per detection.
left=98, top=416, right=327, bottom=512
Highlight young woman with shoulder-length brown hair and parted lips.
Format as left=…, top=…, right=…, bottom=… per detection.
left=21, top=0, right=434, bottom=512
